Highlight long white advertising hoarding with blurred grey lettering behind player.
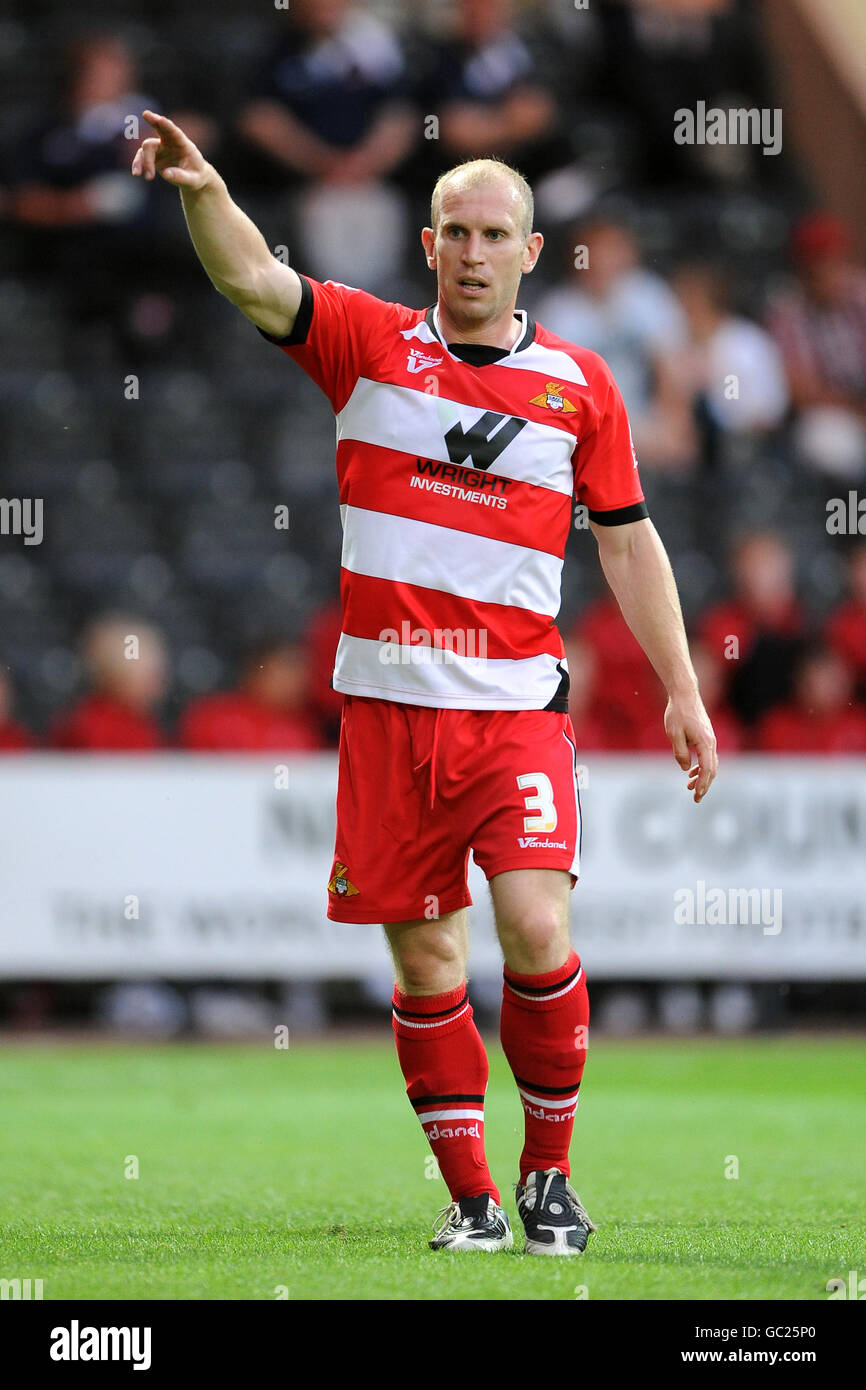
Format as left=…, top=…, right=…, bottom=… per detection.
left=0, top=753, right=866, bottom=980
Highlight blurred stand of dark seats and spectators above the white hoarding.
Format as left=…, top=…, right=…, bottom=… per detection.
left=0, top=0, right=866, bottom=752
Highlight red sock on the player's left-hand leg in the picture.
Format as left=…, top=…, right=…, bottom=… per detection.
left=393, top=980, right=499, bottom=1205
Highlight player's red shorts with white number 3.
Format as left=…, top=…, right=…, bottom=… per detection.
left=328, top=695, right=581, bottom=922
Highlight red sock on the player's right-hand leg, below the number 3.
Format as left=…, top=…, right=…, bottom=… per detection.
left=500, top=951, right=589, bottom=1183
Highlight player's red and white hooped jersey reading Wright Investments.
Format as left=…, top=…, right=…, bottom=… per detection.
left=264, top=277, right=646, bottom=710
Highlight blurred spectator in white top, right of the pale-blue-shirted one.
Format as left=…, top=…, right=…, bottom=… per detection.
left=673, top=263, right=788, bottom=461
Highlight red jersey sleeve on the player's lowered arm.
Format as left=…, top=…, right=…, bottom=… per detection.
left=574, top=354, right=649, bottom=525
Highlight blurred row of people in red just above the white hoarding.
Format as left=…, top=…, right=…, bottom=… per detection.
left=0, top=532, right=866, bottom=753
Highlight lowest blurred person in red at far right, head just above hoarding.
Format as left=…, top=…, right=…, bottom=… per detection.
left=758, top=648, right=866, bottom=753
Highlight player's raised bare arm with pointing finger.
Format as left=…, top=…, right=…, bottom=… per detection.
left=132, top=111, right=300, bottom=338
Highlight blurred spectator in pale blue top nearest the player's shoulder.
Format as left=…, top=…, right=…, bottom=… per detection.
left=535, top=215, right=698, bottom=468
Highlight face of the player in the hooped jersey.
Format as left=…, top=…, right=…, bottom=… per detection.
left=421, top=179, right=542, bottom=328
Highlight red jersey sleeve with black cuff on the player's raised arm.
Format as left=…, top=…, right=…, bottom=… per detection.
left=259, top=275, right=388, bottom=414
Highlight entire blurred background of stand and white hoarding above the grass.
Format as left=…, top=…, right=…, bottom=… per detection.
left=0, top=0, right=866, bottom=1037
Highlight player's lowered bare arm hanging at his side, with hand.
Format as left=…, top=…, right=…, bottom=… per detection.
left=589, top=518, right=719, bottom=802
